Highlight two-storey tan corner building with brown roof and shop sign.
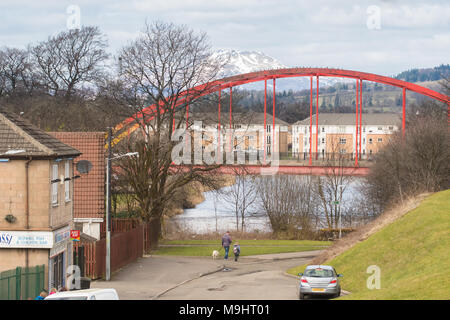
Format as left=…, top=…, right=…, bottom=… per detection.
left=0, top=111, right=80, bottom=288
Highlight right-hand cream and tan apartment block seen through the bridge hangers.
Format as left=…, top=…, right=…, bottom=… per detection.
left=292, top=113, right=401, bottom=158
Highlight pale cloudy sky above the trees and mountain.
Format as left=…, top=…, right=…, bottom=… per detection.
left=0, top=0, right=450, bottom=76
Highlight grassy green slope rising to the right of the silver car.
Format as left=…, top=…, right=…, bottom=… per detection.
left=288, top=190, right=450, bottom=300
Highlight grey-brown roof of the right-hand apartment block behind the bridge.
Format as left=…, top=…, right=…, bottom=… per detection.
left=293, top=113, right=401, bottom=126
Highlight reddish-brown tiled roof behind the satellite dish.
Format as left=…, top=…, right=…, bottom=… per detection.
left=49, top=132, right=106, bottom=218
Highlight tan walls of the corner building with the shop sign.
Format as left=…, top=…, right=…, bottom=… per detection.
left=0, top=160, right=73, bottom=283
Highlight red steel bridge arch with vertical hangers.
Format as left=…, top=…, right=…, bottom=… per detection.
left=113, top=68, right=450, bottom=166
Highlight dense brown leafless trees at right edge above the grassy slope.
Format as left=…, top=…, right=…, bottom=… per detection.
left=368, top=103, right=450, bottom=207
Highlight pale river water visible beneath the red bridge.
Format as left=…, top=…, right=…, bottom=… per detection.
left=172, top=174, right=360, bottom=234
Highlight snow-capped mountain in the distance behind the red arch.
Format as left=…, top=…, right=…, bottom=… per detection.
left=212, top=50, right=349, bottom=91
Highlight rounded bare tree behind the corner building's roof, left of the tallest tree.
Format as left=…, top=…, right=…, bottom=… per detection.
left=30, top=26, right=108, bottom=99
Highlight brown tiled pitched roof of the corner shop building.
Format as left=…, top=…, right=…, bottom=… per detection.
left=0, top=110, right=81, bottom=158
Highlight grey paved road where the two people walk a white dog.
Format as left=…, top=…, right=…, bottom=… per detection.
left=91, top=251, right=320, bottom=300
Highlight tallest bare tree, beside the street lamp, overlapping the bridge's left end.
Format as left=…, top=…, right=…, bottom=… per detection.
left=111, top=22, right=225, bottom=246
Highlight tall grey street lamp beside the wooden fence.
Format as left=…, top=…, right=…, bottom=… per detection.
left=105, top=128, right=138, bottom=281
